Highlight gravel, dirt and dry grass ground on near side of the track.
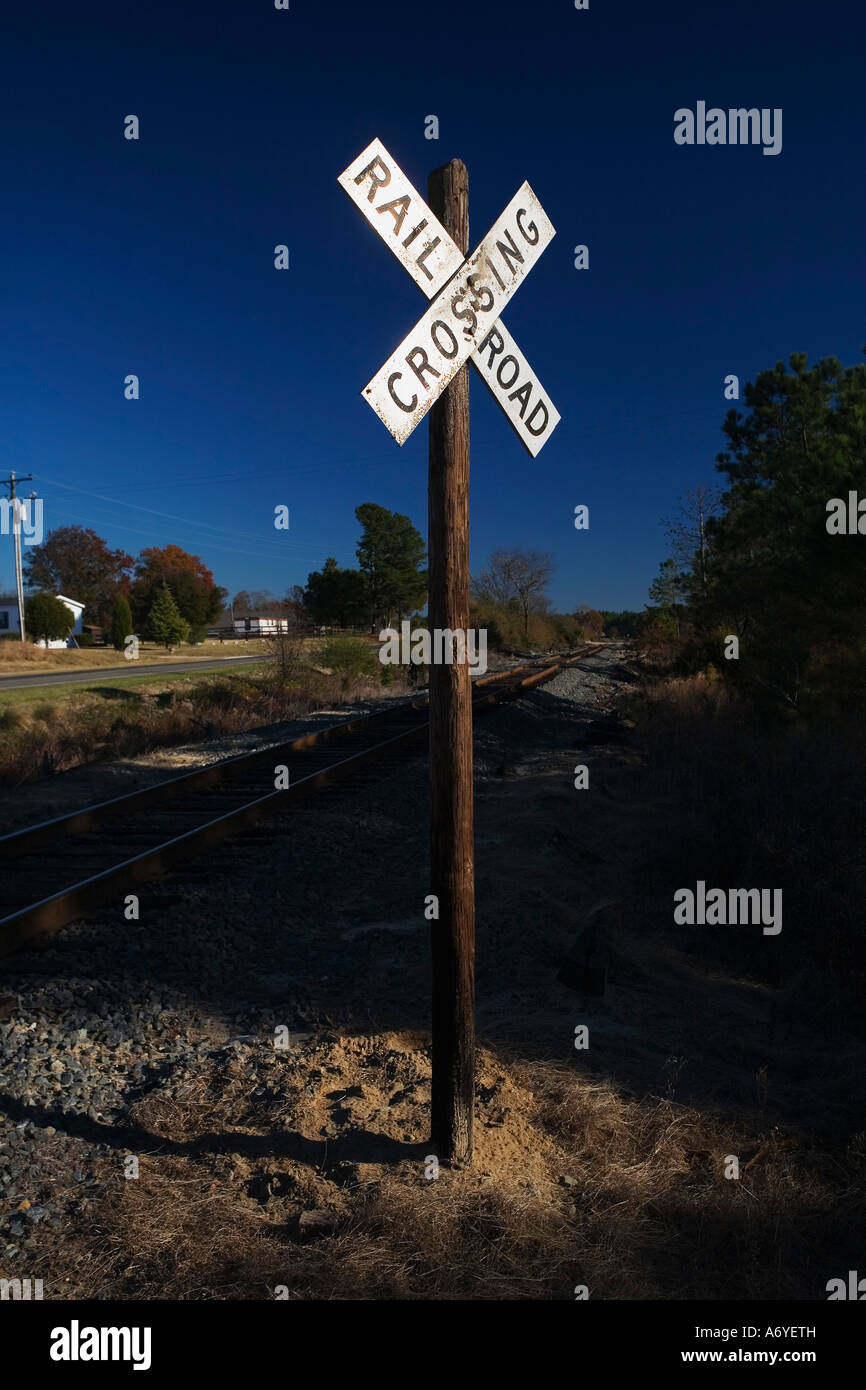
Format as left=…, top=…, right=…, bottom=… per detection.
left=0, top=651, right=866, bottom=1300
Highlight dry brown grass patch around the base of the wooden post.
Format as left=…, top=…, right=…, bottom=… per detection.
left=28, top=1040, right=866, bottom=1300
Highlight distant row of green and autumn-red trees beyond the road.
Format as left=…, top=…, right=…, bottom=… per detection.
left=25, top=502, right=617, bottom=651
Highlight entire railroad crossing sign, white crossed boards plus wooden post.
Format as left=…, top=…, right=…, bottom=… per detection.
left=338, top=140, right=559, bottom=1165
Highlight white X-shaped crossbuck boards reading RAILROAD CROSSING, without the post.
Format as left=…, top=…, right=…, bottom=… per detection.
left=338, top=140, right=560, bottom=457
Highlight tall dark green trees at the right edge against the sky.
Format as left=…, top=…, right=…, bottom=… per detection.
left=651, top=349, right=866, bottom=716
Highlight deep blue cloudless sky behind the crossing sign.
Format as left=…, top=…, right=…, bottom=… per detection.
left=0, top=0, right=866, bottom=610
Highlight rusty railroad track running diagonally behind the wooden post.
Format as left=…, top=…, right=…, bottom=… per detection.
left=0, top=642, right=599, bottom=955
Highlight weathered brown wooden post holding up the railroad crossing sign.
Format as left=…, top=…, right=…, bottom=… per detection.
left=428, top=160, right=475, bottom=1163
